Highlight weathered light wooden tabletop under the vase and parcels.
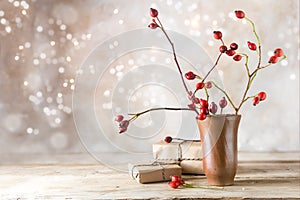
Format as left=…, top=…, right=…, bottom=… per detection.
left=0, top=152, right=300, bottom=199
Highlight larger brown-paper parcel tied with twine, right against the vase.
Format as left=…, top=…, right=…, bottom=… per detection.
left=153, top=140, right=203, bottom=174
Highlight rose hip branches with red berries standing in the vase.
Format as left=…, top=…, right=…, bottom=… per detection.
left=115, top=8, right=286, bottom=133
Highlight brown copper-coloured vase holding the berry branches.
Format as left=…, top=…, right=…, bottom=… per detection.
left=197, top=115, right=241, bottom=186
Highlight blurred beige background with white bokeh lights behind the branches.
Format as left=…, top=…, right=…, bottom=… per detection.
left=0, top=0, right=300, bottom=161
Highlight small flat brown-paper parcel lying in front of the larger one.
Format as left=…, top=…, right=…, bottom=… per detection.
left=128, top=161, right=182, bottom=183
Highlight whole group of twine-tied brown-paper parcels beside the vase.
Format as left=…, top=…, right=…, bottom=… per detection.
left=128, top=139, right=203, bottom=183
